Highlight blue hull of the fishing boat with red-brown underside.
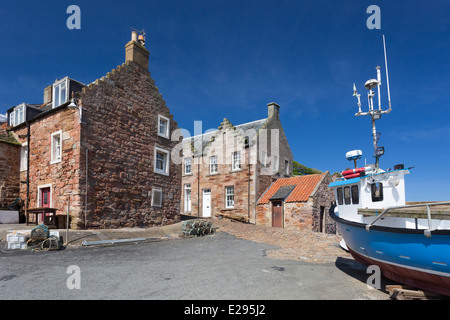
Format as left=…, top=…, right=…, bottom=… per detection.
left=330, top=212, right=450, bottom=296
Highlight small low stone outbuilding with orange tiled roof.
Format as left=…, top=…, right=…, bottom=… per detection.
left=256, top=171, right=336, bottom=233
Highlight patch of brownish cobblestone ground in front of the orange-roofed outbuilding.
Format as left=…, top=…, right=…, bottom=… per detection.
left=213, top=219, right=352, bottom=263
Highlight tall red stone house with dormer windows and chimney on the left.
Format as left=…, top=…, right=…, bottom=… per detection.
left=4, top=32, right=181, bottom=228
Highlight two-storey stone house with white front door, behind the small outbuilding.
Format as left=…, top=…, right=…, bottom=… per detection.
left=181, top=103, right=293, bottom=223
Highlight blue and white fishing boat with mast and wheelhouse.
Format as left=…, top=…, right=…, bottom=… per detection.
left=329, top=35, right=450, bottom=296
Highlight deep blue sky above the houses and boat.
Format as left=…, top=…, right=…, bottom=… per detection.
left=0, top=0, right=450, bottom=201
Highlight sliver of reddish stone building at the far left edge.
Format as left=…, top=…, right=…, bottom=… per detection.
left=0, top=123, right=20, bottom=209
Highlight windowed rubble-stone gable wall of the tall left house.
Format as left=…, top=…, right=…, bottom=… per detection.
left=81, top=61, right=181, bottom=228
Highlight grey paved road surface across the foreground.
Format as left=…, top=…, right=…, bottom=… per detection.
left=0, top=232, right=388, bottom=300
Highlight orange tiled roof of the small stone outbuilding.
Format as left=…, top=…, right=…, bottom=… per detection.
left=258, top=174, right=323, bottom=204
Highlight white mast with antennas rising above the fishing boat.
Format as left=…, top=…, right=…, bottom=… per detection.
left=353, top=35, right=392, bottom=168
